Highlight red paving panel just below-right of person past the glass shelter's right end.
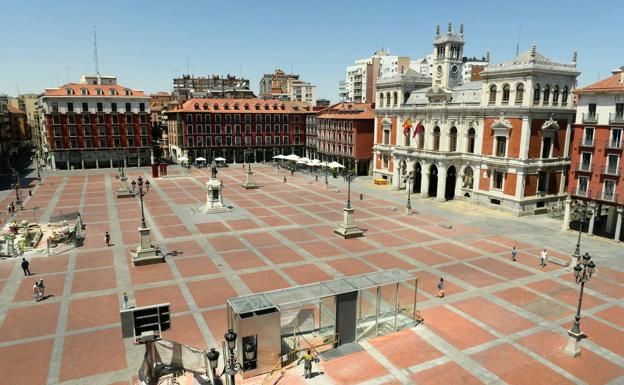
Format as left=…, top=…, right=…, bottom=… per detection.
left=452, top=297, right=535, bottom=334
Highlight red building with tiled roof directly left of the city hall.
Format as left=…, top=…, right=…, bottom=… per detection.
left=317, top=102, right=375, bottom=175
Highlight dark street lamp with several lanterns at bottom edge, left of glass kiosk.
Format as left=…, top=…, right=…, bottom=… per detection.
left=206, top=329, right=256, bottom=385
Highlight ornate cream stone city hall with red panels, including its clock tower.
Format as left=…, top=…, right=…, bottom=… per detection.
left=373, top=23, right=579, bottom=215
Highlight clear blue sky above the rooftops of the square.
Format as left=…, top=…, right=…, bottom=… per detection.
left=0, top=0, right=624, bottom=101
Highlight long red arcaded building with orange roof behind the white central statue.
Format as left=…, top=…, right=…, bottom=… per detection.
left=166, top=98, right=313, bottom=162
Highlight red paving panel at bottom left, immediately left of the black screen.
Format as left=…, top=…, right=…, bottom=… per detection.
left=60, top=328, right=127, bottom=381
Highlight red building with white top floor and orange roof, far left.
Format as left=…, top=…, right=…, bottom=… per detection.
left=38, top=76, right=152, bottom=169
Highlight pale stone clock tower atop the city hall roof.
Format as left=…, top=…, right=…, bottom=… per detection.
left=432, top=22, right=464, bottom=89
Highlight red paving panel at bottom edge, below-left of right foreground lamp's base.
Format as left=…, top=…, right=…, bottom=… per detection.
left=472, top=344, right=573, bottom=385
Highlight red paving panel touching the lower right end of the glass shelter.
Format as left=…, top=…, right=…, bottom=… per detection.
left=421, top=306, right=496, bottom=350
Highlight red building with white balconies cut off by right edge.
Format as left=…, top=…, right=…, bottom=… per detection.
left=564, top=66, right=624, bottom=240
